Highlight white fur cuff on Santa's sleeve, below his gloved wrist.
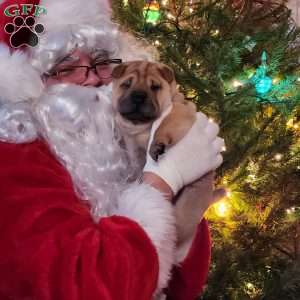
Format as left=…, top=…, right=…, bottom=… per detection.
left=116, top=183, right=176, bottom=292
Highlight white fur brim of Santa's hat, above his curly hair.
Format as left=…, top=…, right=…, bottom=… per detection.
left=39, top=0, right=111, bottom=32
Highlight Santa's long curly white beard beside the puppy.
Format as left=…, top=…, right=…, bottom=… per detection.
left=34, top=84, right=133, bottom=219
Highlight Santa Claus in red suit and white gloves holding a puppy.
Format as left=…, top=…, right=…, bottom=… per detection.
left=0, top=0, right=223, bottom=300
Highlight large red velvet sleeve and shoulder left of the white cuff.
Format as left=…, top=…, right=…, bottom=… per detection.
left=0, top=141, right=158, bottom=300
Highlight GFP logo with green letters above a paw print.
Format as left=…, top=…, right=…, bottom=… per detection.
left=4, top=4, right=47, bottom=48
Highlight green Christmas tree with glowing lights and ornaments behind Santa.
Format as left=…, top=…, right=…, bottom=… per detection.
left=113, top=0, right=300, bottom=300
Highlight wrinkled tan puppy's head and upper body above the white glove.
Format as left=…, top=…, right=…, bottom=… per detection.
left=112, top=61, right=196, bottom=168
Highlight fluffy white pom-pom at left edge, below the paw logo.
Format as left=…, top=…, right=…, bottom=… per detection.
left=0, top=43, right=43, bottom=102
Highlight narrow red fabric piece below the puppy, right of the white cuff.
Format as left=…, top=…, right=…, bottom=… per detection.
left=167, top=219, right=211, bottom=300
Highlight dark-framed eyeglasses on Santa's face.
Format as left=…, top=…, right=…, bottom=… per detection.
left=44, top=58, right=122, bottom=84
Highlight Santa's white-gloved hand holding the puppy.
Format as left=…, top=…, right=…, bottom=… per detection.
left=144, top=112, right=224, bottom=194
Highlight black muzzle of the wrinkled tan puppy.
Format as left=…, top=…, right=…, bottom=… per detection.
left=119, top=90, right=157, bottom=123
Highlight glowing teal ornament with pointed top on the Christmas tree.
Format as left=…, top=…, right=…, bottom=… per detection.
left=251, top=51, right=273, bottom=95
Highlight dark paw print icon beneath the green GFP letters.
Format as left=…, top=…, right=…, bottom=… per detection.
left=4, top=16, right=45, bottom=48
